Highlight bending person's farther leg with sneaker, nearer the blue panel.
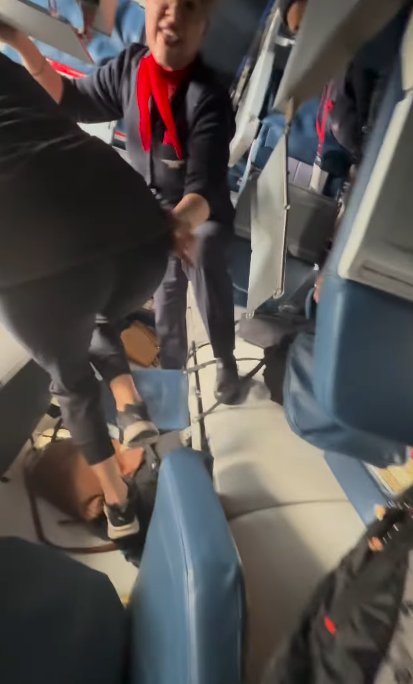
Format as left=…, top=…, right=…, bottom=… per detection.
left=90, top=239, right=170, bottom=448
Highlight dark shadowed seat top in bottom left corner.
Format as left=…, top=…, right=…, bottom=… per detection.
left=0, top=538, right=127, bottom=684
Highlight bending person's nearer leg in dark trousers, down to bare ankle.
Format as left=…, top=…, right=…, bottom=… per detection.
left=0, top=260, right=132, bottom=504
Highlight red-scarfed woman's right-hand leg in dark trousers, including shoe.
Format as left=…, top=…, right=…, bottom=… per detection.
left=184, top=221, right=239, bottom=403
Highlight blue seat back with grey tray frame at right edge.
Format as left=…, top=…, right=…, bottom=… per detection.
left=314, top=57, right=413, bottom=444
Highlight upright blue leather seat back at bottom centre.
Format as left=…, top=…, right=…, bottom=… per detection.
left=128, top=449, right=245, bottom=684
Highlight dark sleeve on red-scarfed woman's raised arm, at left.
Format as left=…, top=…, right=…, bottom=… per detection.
left=60, top=48, right=135, bottom=123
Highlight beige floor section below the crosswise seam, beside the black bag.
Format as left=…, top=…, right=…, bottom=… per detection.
left=231, top=501, right=364, bottom=684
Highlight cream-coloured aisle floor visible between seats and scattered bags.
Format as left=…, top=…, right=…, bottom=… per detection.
left=0, top=295, right=363, bottom=682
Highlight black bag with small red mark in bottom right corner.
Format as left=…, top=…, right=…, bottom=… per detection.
left=263, top=496, right=413, bottom=684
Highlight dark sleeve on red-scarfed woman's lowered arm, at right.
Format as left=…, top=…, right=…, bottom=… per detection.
left=184, top=91, right=235, bottom=213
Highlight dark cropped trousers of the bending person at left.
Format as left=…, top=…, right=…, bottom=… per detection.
left=0, top=237, right=170, bottom=465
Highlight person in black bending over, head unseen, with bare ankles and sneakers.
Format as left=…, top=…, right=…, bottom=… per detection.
left=0, top=50, right=190, bottom=560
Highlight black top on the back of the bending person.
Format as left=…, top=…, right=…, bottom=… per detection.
left=0, top=54, right=169, bottom=292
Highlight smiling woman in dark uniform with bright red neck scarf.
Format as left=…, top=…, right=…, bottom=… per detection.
left=0, top=0, right=239, bottom=403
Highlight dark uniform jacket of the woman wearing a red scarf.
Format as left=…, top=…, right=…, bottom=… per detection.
left=61, top=44, right=235, bottom=224
